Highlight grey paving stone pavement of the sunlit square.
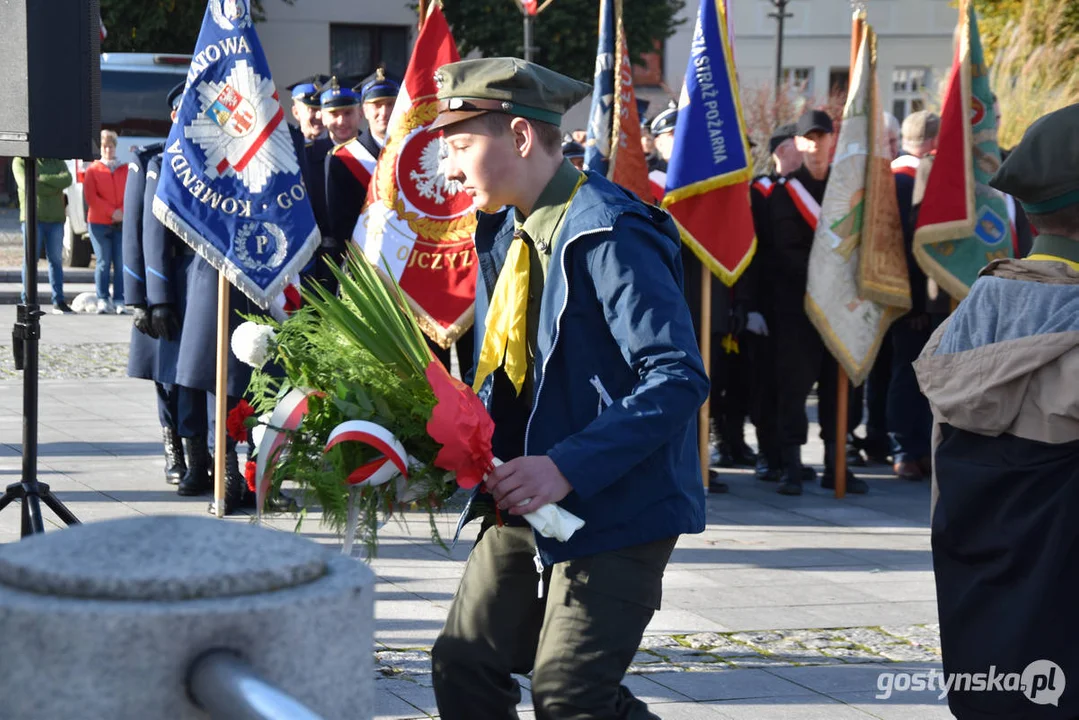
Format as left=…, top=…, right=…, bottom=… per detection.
left=0, top=309, right=951, bottom=720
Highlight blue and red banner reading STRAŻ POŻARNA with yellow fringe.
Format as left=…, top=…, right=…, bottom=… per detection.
left=663, top=0, right=756, bottom=285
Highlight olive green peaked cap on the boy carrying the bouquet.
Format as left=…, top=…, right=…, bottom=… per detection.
left=431, top=57, right=592, bottom=130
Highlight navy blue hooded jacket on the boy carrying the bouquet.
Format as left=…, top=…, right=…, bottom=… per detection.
left=476, top=173, right=709, bottom=565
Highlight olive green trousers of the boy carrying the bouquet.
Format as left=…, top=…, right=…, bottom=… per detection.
left=432, top=518, right=677, bottom=720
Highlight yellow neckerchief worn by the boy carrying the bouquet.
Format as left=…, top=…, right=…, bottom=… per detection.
left=473, top=173, right=587, bottom=395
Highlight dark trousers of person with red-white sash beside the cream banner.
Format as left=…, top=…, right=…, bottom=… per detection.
left=775, top=310, right=862, bottom=451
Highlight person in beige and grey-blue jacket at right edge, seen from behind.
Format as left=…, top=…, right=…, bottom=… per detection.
left=915, top=105, right=1079, bottom=720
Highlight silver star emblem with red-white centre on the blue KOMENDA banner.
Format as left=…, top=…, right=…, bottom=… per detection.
left=183, top=59, right=300, bottom=193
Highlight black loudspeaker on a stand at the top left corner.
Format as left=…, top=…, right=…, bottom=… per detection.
left=0, top=0, right=101, bottom=159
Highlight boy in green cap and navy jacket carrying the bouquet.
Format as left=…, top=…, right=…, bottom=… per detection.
left=432, top=58, right=709, bottom=720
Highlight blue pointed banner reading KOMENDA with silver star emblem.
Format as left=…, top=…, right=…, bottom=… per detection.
left=153, top=0, right=320, bottom=308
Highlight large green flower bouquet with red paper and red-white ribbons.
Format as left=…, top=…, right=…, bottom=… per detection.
left=233, top=250, right=583, bottom=555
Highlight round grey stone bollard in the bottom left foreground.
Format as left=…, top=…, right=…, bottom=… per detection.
left=0, top=516, right=375, bottom=720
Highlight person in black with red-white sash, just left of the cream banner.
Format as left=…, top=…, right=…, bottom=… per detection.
left=768, top=110, right=869, bottom=495
